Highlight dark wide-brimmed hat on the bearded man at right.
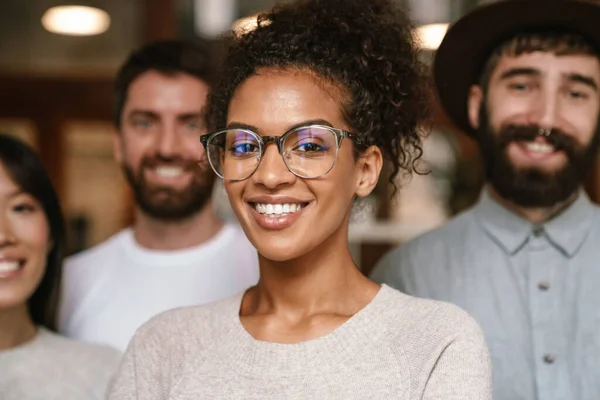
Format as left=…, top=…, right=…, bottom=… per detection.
left=433, top=0, right=600, bottom=134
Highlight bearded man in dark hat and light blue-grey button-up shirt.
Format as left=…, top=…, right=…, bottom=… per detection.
left=372, top=0, right=600, bottom=400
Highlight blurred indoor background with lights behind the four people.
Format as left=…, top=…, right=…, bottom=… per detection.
left=0, top=0, right=600, bottom=272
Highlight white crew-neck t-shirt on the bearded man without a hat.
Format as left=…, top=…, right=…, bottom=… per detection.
left=59, top=225, right=259, bottom=350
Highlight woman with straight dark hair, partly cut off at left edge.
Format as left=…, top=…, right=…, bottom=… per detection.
left=0, top=135, right=120, bottom=400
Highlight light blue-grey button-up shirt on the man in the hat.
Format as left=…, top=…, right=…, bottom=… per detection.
left=371, top=191, right=600, bottom=400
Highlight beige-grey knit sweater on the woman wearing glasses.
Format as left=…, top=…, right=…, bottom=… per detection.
left=109, top=285, right=491, bottom=400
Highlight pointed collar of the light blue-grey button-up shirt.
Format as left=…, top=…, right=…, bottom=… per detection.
left=474, top=189, right=594, bottom=257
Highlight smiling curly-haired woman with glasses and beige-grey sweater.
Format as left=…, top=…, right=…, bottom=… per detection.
left=111, top=0, right=491, bottom=400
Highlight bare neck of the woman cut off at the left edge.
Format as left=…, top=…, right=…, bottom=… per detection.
left=0, top=304, right=37, bottom=350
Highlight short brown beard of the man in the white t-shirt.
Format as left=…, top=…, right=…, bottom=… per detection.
left=122, top=157, right=215, bottom=221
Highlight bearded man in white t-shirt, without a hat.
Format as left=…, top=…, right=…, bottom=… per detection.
left=59, top=40, right=258, bottom=350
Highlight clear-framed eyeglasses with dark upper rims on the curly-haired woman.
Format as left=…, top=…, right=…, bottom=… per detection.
left=200, top=125, right=361, bottom=181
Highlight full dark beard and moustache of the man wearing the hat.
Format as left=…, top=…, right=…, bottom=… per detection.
left=476, top=106, right=600, bottom=208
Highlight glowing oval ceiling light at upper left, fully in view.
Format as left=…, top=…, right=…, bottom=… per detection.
left=42, top=6, right=110, bottom=36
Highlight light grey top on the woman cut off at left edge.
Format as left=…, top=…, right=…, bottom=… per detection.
left=0, top=327, right=121, bottom=400
